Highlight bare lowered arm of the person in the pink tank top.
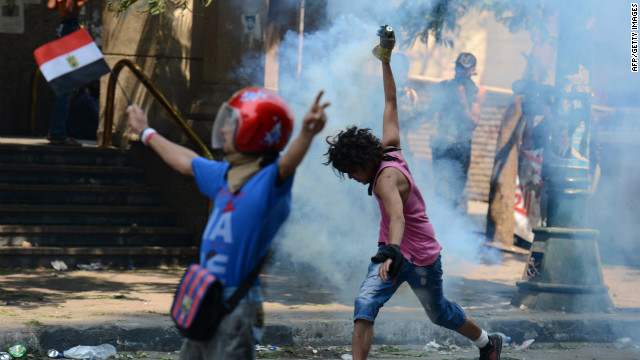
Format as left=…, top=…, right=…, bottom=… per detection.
left=375, top=167, right=405, bottom=282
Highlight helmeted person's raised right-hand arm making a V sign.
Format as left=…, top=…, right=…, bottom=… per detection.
left=278, top=91, right=330, bottom=181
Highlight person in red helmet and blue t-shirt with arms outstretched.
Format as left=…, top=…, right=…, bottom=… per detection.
left=127, top=87, right=329, bottom=360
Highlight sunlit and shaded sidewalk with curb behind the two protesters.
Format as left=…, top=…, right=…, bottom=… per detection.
left=0, top=253, right=640, bottom=351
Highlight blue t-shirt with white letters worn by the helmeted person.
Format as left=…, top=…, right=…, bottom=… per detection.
left=191, top=157, right=293, bottom=287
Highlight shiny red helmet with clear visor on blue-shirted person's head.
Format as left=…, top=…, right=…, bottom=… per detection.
left=211, top=86, right=293, bottom=152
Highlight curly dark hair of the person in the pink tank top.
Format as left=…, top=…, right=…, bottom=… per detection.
left=323, top=126, right=384, bottom=178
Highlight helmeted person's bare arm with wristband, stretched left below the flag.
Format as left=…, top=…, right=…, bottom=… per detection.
left=127, top=104, right=198, bottom=176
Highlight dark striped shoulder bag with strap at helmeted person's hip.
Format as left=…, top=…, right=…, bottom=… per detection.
left=171, top=257, right=264, bottom=341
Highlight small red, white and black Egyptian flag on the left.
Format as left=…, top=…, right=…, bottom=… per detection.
left=33, top=28, right=111, bottom=95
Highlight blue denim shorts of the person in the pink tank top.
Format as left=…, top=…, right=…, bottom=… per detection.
left=353, top=245, right=467, bottom=331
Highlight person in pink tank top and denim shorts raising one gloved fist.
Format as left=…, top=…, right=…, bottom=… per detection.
left=325, top=25, right=502, bottom=360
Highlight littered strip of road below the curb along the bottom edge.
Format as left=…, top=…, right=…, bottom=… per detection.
left=109, top=343, right=640, bottom=360
